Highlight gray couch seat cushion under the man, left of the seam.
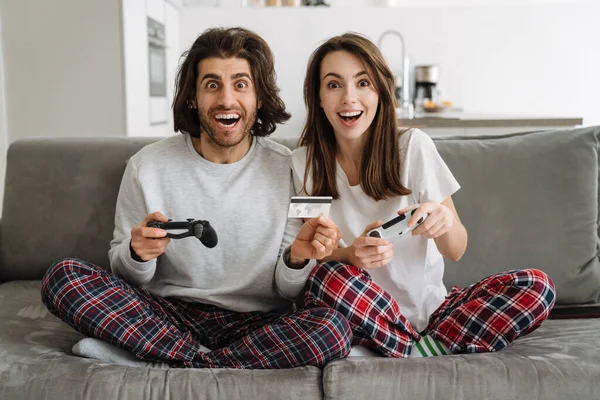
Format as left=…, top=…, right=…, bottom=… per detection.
left=0, top=281, right=322, bottom=400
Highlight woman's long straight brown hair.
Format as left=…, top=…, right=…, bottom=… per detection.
left=300, top=33, right=411, bottom=200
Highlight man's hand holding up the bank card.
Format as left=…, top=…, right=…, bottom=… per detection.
left=290, top=217, right=342, bottom=264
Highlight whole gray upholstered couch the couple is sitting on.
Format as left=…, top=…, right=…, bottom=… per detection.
left=0, top=127, right=600, bottom=400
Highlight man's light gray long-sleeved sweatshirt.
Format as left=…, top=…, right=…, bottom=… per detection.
left=109, top=134, right=316, bottom=312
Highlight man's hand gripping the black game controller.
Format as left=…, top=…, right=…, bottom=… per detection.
left=131, top=211, right=171, bottom=262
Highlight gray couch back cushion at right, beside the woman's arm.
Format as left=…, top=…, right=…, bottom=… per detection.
left=435, top=127, right=600, bottom=303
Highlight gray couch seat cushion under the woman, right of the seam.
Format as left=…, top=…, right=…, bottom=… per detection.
left=323, top=319, right=600, bottom=400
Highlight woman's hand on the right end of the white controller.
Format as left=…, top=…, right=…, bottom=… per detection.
left=398, top=201, right=455, bottom=239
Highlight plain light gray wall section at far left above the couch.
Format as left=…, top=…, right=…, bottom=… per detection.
left=0, top=0, right=125, bottom=142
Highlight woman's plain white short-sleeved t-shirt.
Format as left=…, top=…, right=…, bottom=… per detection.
left=292, top=129, right=460, bottom=331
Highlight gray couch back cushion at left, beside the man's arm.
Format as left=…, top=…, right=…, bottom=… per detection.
left=0, top=138, right=156, bottom=281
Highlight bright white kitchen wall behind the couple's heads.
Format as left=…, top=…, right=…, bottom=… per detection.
left=181, top=0, right=600, bottom=136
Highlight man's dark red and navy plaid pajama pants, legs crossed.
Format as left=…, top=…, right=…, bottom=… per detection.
left=41, top=259, right=352, bottom=368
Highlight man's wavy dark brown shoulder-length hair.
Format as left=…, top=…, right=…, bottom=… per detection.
left=173, top=27, right=290, bottom=137
